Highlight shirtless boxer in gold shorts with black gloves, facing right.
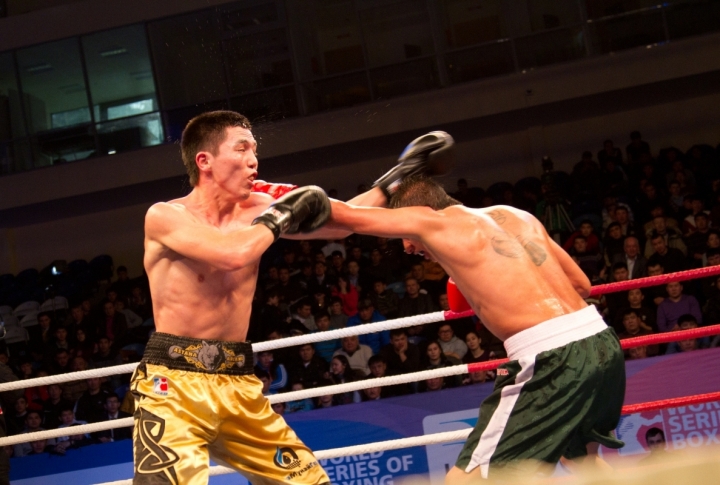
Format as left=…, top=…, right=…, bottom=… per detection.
left=131, top=111, right=452, bottom=485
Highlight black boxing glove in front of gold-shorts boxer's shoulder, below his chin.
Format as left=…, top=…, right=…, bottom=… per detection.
left=252, top=185, right=331, bottom=240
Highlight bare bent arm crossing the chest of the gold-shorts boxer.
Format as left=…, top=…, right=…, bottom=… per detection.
left=145, top=199, right=274, bottom=271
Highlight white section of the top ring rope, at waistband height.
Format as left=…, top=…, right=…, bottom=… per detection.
left=0, top=312, right=445, bottom=392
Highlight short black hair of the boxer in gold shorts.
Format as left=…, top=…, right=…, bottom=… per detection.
left=180, top=111, right=252, bottom=186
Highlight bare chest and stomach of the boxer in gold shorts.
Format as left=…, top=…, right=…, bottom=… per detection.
left=144, top=192, right=267, bottom=341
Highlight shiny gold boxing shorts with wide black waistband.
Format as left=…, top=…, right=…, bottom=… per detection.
left=130, top=333, right=330, bottom=485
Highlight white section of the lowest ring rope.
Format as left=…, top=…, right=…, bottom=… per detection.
left=100, top=428, right=472, bottom=485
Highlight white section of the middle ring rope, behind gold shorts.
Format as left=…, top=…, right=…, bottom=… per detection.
left=0, top=364, right=468, bottom=447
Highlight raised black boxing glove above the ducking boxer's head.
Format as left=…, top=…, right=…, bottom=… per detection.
left=373, top=131, right=455, bottom=200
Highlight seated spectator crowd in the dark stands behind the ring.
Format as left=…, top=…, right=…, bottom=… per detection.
left=0, top=132, right=720, bottom=456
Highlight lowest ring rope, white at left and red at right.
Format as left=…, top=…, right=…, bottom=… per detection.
left=94, top=392, right=720, bottom=485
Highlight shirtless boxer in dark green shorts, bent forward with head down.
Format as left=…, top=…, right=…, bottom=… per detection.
left=332, top=177, right=625, bottom=485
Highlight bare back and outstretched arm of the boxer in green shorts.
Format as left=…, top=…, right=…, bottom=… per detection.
left=333, top=204, right=590, bottom=340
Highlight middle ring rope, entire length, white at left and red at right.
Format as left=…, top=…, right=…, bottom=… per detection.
left=0, top=325, right=720, bottom=446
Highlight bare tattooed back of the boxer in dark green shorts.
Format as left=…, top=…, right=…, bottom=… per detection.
left=423, top=206, right=587, bottom=339
